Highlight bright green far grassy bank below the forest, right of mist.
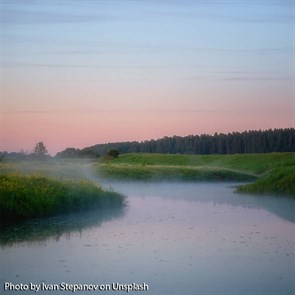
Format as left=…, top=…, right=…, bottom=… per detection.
left=97, top=153, right=295, bottom=196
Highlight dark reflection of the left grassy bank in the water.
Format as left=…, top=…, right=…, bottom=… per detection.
left=0, top=207, right=126, bottom=248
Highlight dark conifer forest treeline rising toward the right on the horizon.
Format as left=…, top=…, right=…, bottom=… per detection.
left=56, top=128, right=295, bottom=158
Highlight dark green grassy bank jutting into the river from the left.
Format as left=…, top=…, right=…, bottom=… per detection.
left=0, top=174, right=125, bottom=222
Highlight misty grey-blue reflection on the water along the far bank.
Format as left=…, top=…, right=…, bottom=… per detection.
left=105, top=181, right=295, bottom=223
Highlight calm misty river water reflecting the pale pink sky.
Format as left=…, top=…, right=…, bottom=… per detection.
left=0, top=182, right=295, bottom=295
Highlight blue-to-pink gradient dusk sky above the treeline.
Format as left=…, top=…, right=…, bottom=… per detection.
left=0, top=0, right=295, bottom=155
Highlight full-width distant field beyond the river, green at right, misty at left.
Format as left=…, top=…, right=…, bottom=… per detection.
left=0, top=153, right=295, bottom=196
